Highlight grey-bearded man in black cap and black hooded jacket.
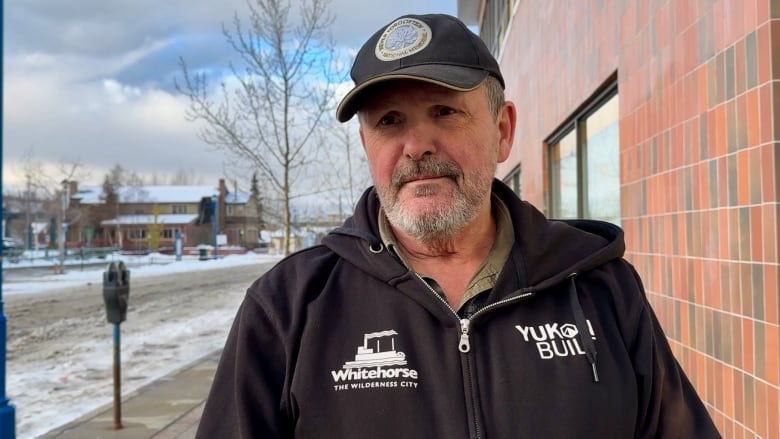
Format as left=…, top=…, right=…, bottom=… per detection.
left=198, top=15, right=719, bottom=439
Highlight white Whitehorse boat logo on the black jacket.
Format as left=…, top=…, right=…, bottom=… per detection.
left=331, top=329, right=418, bottom=391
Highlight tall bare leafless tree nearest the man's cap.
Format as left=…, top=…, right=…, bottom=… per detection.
left=175, top=0, right=340, bottom=254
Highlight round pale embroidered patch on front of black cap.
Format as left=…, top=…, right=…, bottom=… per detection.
left=374, top=18, right=432, bottom=61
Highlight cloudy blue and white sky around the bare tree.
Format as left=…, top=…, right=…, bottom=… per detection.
left=2, top=0, right=457, bottom=192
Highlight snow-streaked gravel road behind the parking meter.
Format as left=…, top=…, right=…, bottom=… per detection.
left=4, top=262, right=273, bottom=437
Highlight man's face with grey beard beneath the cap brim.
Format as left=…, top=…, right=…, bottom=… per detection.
left=359, top=81, right=514, bottom=242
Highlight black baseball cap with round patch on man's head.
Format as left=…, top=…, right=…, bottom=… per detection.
left=336, top=14, right=505, bottom=122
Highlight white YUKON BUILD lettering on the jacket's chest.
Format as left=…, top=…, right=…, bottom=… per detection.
left=515, top=320, right=596, bottom=360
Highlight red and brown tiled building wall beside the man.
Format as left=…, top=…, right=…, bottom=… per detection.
left=496, top=0, right=780, bottom=438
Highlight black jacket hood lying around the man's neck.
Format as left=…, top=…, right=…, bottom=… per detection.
left=323, top=180, right=625, bottom=291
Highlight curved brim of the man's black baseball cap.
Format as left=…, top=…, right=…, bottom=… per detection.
left=336, top=64, right=489, bottom=122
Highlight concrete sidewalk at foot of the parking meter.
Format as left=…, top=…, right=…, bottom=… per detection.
left=40, top=352, right=220, bottom=439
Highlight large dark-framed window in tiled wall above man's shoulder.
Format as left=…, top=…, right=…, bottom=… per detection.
left=548, top=84, right=620, bottom=225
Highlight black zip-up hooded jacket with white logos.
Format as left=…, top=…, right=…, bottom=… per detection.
left=197, top=181, right=719, bottom=439
